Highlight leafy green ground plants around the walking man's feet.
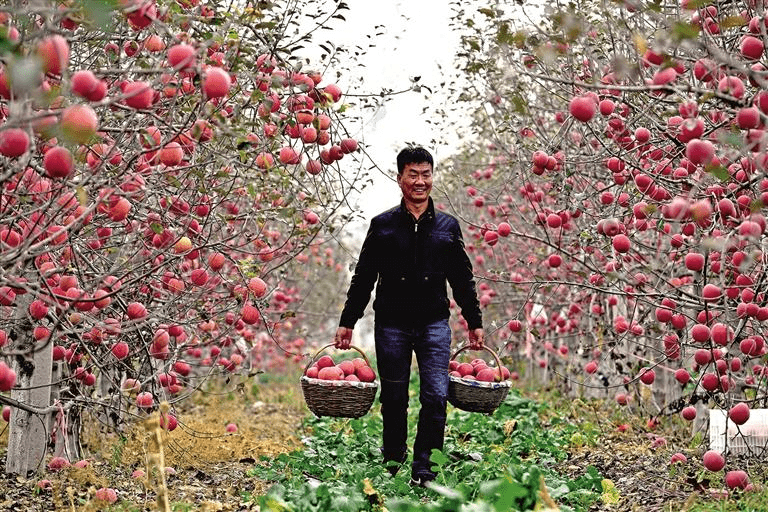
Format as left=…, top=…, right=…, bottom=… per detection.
left=250, top=372, right=603, bottom=512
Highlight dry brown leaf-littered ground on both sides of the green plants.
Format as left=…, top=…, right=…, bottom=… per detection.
left=0, top=382, right=768, bottom=512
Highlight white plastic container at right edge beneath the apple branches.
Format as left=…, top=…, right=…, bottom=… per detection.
left=709, top=409, right=768, bottom=457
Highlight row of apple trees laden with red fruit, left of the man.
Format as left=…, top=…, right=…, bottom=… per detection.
left=0, top=0, right=361, bottom=473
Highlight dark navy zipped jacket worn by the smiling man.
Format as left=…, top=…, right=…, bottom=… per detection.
left=339, top=198, right=482, bottom=329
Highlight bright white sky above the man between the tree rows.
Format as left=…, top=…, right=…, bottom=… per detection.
left=326, top=0, right=468, bottom=225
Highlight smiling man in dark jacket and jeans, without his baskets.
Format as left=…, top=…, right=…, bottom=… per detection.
left=334, top=147, right=484, bottom=486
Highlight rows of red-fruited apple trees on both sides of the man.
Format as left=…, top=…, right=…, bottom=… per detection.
left=0, top=0, right=768, bottom=492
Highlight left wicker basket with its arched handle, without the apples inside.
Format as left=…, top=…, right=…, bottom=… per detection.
left=300, top=343, right=379, bottom=418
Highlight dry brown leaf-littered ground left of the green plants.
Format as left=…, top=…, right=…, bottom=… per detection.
left=0, top=376, right=306, bottom=511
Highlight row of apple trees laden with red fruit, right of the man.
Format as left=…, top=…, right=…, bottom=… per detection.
left=441, top=0, right=768, bottom=460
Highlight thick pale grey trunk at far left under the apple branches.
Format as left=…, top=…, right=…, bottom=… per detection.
left=5, top=290, right=53, bottom=475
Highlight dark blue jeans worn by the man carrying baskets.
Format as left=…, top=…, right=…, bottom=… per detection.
left=374, top=319, right=451, bottom=479
